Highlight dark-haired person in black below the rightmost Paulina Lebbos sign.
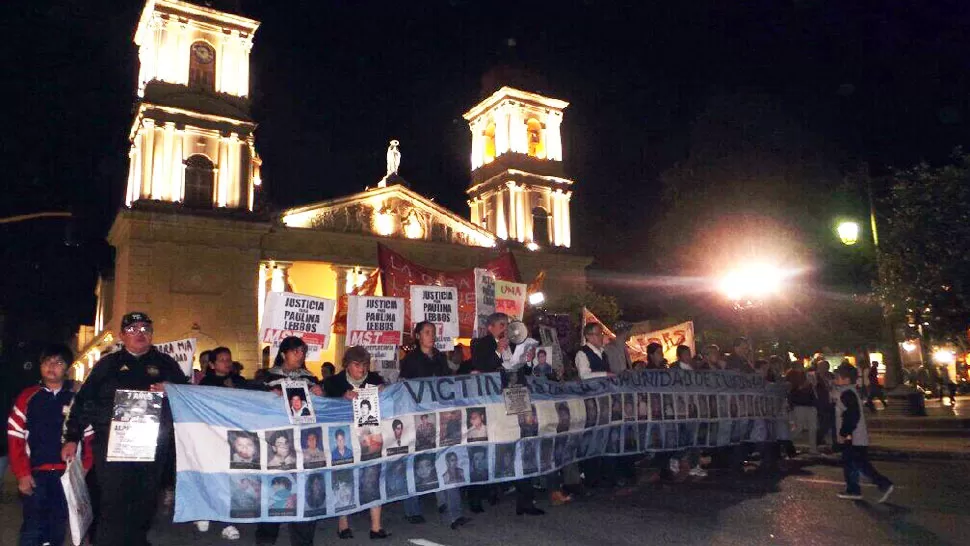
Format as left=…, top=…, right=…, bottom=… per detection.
left=399, top=321, right=469, bottom=529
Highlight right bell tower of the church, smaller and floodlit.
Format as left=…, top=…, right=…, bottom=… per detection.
left=464, top=87, right=573, bottom=250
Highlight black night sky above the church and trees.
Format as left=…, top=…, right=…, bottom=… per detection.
left=0, top=0, right=970, bottom=346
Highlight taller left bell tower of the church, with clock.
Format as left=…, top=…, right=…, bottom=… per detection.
left=125, top=0, right=260, bottom=211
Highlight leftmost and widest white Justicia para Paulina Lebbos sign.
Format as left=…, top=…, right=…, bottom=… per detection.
left=259, top=292, right=336, bottom=349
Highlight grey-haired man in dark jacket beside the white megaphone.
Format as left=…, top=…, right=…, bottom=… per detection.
left=469, top=313, right=545, bottom=516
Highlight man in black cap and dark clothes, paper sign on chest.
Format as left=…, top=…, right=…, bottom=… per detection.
left=61, top=312, right=188, bottom=546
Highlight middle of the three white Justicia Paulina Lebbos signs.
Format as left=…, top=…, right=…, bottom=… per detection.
left=347, top=296, right=404, bottom=361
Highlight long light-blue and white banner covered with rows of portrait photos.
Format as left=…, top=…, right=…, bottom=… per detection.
left=166, top=369, right=788, bottom=522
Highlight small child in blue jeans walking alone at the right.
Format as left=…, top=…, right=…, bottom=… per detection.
left=835, top=363, right=894, bottom=503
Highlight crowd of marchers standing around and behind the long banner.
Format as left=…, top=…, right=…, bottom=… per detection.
left=0, top=312, right=892, bottom=546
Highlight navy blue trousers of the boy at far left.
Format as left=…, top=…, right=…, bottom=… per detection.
left=20, top=470, right=67, bottom=546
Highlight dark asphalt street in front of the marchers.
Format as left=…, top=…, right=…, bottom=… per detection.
left=0, top=461, right=970, bottom=546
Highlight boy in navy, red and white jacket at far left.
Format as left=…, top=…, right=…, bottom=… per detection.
left=7, top=344, right=93, bottom=545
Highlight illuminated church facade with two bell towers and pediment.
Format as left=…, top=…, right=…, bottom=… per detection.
left=74, top=0, right=591, bottom=378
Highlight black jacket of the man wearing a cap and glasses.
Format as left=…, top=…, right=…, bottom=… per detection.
left=64, top=347, right=189, bottom=444
